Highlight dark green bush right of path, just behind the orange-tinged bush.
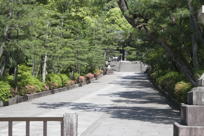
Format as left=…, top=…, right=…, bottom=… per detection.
left=156, top=72, right=183, bottom=94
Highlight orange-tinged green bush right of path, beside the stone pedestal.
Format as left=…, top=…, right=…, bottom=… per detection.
left=175, top=81, right=192, bottom=103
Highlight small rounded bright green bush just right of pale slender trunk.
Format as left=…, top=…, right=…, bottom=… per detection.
left=46, top=74, right=62, bottom=89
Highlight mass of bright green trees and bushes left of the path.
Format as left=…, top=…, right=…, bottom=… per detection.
left=0, top=0, right=132, bottom=98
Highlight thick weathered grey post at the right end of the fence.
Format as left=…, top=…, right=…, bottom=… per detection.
left=64, top=113, right=78, bottom=136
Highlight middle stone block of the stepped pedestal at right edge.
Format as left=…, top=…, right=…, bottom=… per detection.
left=181, top=104, right=204, bottom=126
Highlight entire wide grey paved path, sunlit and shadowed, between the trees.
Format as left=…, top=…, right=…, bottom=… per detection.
left=0, top=63, right=179, bottom=136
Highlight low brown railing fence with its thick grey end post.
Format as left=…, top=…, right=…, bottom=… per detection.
left=0, top=113, right=78, bottom=136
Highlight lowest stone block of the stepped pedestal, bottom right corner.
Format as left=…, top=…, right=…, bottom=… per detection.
left=174, top=123, right=204, bottom=136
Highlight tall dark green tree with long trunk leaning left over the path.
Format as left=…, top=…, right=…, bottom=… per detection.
left=118, top=0, right=202, bottom=86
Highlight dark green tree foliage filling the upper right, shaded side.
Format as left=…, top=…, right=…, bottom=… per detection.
left=118, top=0, right=204, bottom=86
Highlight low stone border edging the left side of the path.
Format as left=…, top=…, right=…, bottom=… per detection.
left=0, top=74, right=103, bottom=107
